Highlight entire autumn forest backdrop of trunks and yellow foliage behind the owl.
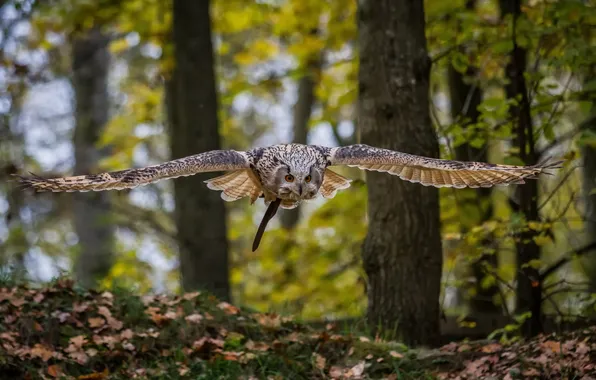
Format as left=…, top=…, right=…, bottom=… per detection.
left=0, top=0, right=596, bottom=343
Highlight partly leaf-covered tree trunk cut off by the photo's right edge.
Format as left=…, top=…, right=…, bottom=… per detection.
left=582, top=65, right=596, bottom=293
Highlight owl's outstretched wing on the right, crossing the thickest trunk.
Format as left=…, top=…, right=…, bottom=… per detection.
left=329, top=144, right=562, bottom=188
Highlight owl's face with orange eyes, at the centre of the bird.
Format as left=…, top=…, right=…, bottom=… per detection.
left=275, top=165, right=323, bottom=200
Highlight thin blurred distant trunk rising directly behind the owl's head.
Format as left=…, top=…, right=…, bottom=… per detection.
left=279, top=62, right=319, bottom=230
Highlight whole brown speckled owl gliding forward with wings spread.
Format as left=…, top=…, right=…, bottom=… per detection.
left=17, top=144, right=561, bottom=251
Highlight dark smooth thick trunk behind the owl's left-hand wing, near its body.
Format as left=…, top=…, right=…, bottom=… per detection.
left=167, top=0, right=230, bottom=300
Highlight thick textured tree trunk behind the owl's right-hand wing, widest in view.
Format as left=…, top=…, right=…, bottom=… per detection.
left=358, top=0, right=442, bottom=345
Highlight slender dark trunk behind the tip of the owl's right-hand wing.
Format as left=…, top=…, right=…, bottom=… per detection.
left=500, top=0, right=542, bottom=336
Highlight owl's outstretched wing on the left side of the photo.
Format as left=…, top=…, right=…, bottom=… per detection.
left=16, top=150, right=250, bottom=192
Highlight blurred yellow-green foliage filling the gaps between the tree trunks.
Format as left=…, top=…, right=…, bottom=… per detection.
left=0, top=0, right=596, bottom=324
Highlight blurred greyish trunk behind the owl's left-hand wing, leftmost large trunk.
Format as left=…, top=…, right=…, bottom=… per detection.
left=72, top=28, right=114, bottom=287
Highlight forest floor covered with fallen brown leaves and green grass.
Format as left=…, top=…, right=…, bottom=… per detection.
left=0, top=278, right=596, bottom=380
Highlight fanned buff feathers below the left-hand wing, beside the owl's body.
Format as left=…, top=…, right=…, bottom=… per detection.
left=205, top=170, right=262, bottom=203
